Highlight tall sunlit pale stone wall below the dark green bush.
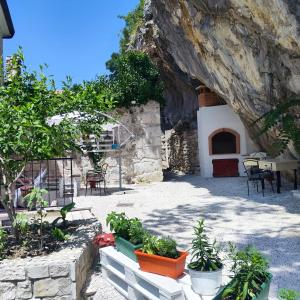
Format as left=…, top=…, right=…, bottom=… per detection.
left=74, top=101, right=163, bottom=183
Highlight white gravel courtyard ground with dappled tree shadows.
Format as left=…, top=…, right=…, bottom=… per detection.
left=75, top=176, right=300, bottom=299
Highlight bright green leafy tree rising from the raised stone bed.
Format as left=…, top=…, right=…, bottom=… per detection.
left=0, top=50, right=112, bottom=238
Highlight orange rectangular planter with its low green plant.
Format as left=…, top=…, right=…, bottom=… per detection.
left=135, top=233, right=188, bottom=279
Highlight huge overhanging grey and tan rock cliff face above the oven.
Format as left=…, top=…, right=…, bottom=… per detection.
left=135, top=0, right=300, bottom=155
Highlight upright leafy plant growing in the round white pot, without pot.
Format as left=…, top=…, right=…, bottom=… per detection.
left=188, top=220, right=223, bottom=271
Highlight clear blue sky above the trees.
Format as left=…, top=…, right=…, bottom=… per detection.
left=4, top=0, right=138, bottom=85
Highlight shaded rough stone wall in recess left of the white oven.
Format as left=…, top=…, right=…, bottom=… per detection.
left=162, top=122, right=200, bottom=174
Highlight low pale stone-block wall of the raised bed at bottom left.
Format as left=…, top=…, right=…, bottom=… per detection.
left=0, top=221, right=97, bottom=300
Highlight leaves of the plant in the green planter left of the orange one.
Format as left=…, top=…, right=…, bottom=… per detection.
left=106, top=211, right=145, bottom=245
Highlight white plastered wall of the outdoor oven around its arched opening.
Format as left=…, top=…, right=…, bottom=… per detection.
left=197, top=105, right=256, bottom=177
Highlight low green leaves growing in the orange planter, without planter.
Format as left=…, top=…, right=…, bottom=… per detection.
left=141, top=233, right=179, bottom=258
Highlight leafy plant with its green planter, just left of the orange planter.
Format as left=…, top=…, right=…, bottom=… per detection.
left=106, top=211, right=145, bottom=261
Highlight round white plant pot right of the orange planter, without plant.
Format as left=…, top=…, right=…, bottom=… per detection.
left=189, top=269, right=223, bottom=296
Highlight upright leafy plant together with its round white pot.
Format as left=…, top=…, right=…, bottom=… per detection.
left=188, top=220, right=223, bottom=295
